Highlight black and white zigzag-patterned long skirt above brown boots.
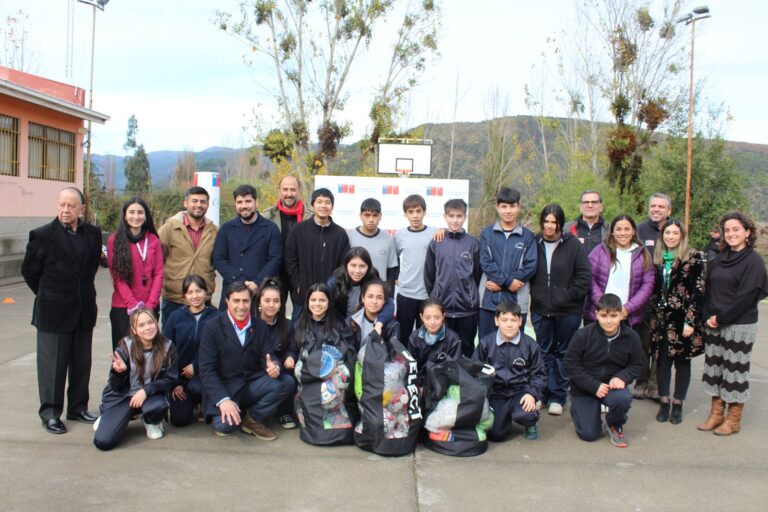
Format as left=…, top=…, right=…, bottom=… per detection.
left=701, top=323, right=757, bottom=403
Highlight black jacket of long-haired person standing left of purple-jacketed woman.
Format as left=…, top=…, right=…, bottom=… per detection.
left=531, top=233, right=592, bottom=316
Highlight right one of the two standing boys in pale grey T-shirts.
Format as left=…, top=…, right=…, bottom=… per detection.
left=395, top=194, right=437, bottom=340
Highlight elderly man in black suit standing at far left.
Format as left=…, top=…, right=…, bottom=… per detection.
left=21, top=187, right=101, bottom=434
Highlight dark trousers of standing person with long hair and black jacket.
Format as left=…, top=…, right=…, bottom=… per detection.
left=531, top=313, right=581, bottom=405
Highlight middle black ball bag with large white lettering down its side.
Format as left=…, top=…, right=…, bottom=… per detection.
left=354, top=331, right=422, bottom=456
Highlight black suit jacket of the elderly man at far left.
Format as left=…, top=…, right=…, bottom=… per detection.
left=21, top=219, right=101, bottom=333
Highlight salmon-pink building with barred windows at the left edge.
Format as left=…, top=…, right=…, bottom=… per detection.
left=0, top=66, right=109, bottom=282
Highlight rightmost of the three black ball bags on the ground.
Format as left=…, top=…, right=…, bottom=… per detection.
left=423, top=354, right=494, bottom=457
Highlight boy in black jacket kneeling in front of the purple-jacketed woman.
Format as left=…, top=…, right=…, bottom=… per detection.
left=565, top=293, right=645, bottom=448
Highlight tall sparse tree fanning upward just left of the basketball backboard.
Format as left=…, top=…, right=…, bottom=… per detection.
left=216, top=0, right=437, bottom=189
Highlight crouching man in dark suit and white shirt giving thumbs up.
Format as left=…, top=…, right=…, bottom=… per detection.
left=198, top=281, right=295, bottom=441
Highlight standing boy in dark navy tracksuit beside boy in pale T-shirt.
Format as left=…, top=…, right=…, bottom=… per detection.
left=424, top=199, right=481, bottom=357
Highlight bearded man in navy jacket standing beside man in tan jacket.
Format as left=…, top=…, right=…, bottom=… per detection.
left=213, top=185, right=283, bottom=311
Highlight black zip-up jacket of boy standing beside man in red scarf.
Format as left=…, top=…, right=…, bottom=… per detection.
left=283, top=217, right=349, bottom=304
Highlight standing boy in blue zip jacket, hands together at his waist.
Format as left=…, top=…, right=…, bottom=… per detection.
left=480, top=187, right=538, bottom=338
